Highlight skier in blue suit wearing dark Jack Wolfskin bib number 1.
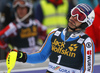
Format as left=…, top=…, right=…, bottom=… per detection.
left=8, top=3, right=95, bottom=73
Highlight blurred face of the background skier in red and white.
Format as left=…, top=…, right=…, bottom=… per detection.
left=16, top=6, right=28, bottom=18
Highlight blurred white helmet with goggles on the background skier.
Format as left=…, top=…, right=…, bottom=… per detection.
left=13, top=0, right=33, bottom=22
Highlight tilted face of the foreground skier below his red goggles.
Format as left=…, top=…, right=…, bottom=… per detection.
left=68, top=16, right=82, bottom=29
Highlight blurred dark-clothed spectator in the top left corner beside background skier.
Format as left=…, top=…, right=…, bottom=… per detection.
left=1, top=0, right=15, bottom=28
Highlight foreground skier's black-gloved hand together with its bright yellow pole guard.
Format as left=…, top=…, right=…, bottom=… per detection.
left=6, top=49, right=27, bottom=73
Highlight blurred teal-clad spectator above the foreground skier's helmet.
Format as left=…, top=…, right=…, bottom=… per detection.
left=77, top=0, right=98, bottom=9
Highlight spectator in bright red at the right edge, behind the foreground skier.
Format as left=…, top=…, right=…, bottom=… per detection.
left=85, top=3, right=100, bottom=52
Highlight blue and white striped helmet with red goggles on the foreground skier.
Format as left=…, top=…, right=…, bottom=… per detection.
left=71, top=3, right=95, bottom=29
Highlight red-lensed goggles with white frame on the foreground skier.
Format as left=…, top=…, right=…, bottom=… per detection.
left=71, top=7, right=87, bottom=23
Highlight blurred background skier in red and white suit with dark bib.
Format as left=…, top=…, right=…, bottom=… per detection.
left=0, top=0, right=46, bottom=53
